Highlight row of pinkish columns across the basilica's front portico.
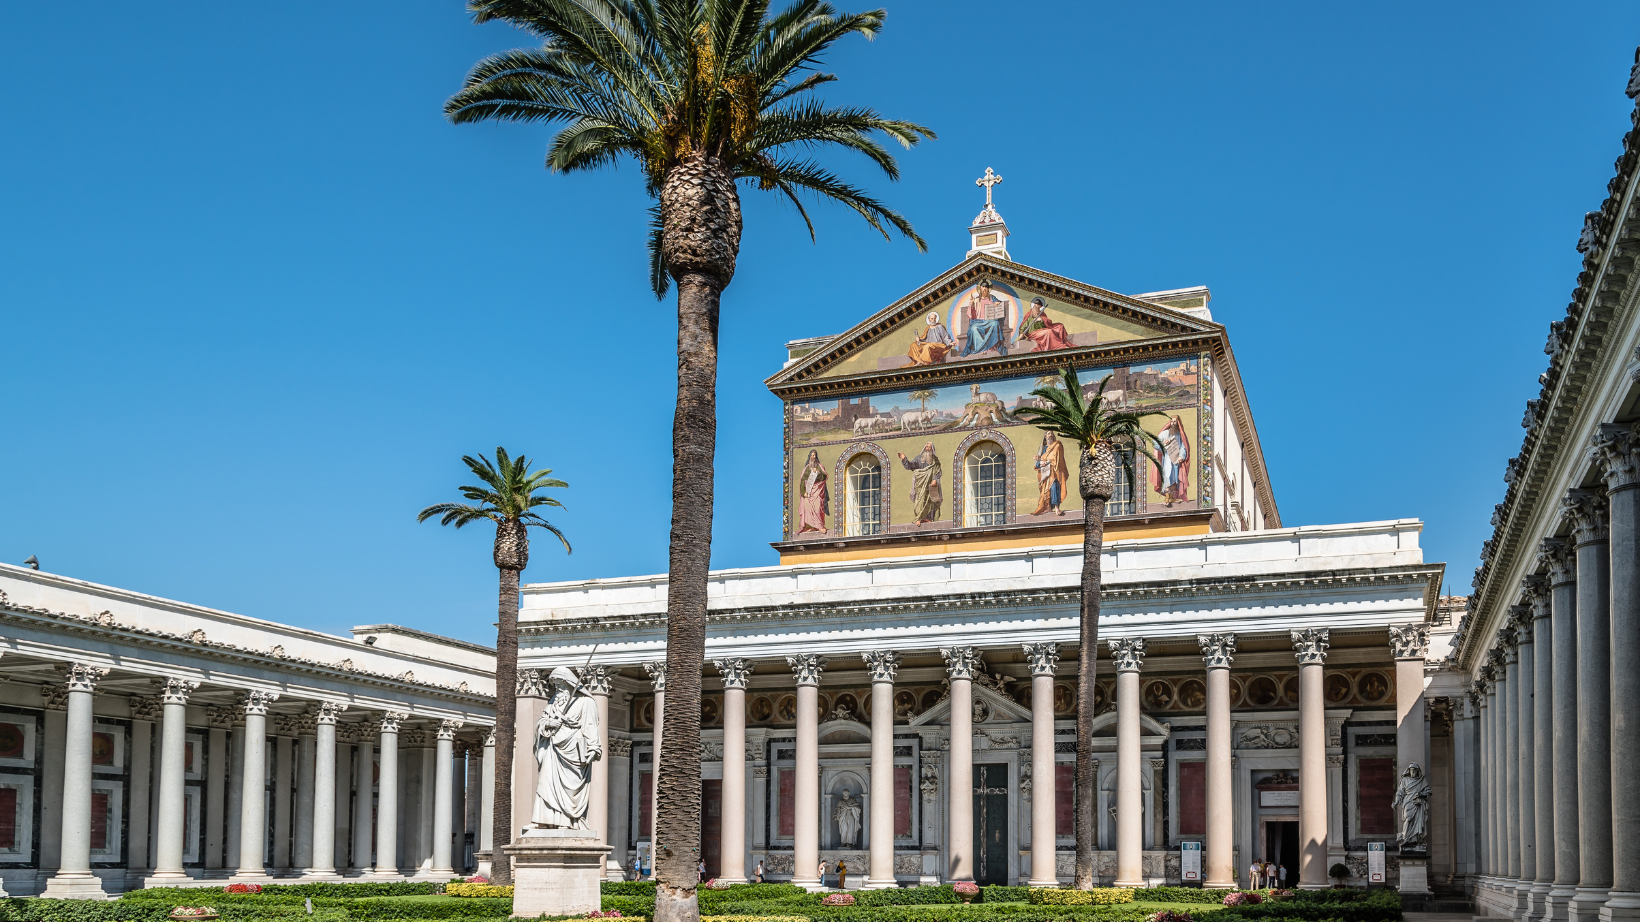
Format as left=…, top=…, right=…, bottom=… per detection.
left=616, top=625, right=1397, bottom=889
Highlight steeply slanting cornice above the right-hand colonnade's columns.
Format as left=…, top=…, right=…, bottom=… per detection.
left=1455, top=98, right=1640, bottom=671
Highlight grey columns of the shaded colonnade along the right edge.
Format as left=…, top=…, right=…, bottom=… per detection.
left=1469, top=425, right=1640, bottom=922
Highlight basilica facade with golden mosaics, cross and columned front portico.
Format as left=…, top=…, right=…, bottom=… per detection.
left=515, top=191, right=1473, bottom=894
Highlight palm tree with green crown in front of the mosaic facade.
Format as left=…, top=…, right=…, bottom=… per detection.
left=1015, top=367, right=1164, bottom=889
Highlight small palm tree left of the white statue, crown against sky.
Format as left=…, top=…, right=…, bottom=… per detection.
left=415, top=446, right=571, bottom=884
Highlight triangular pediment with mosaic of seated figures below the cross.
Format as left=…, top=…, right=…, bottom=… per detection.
left=768, top=254, right=1223, bottom=390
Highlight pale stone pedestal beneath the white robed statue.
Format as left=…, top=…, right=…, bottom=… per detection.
left=502, top=828, right=610, bottom=919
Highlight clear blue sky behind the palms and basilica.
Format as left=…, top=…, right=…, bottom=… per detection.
left=0, top=0, right=1640, bottom=640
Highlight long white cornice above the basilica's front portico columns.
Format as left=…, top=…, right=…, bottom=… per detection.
left=518, top=564, right=1445, bottom=637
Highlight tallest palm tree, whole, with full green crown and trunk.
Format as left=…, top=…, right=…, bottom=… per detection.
left=444, top=0, right=933, bottom=922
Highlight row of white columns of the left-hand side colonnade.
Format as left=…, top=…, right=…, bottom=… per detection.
left=30, top=663, right=494, bottom=899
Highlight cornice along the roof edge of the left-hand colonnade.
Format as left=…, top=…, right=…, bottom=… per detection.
left=0, top=589, right=494, bottom=707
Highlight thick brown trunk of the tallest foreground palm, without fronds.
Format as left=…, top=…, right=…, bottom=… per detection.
left=651, top=153, right=741, bottom=922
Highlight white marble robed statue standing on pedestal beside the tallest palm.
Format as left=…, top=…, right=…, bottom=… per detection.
left=530, top=666, right=604, bottom=828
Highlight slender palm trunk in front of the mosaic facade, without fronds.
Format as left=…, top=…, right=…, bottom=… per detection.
left=1076, top=443, right=1115, bottom=889
